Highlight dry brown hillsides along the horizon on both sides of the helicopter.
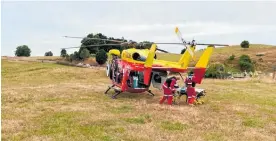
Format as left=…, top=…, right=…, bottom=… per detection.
left=2, top=44, right=276, bottom=72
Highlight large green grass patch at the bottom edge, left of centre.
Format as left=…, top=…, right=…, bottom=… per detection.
left=32, top=112, right=116, bottom=141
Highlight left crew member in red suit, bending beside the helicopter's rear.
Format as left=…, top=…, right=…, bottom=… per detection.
left=159, top=77, right=177, bottom=105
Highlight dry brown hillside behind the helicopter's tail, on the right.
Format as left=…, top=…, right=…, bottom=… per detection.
left=158, top=44, right=276, bottom=71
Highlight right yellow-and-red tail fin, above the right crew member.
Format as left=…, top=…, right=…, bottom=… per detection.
left=194, top=46, right=214, bottom=84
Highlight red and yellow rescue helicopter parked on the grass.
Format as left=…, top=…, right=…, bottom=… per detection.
left=62, top=27, right=228, bottom=99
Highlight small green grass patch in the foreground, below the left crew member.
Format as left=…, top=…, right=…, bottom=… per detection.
left=161, top=121, right=188, bottom=131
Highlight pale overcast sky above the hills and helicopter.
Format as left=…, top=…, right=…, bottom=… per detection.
left=1, top=1, right=276, bottom=56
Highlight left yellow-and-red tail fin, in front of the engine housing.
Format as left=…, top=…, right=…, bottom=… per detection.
left=144, top=44, right=156, bottom=85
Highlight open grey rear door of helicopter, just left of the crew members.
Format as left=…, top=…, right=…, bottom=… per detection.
left=151, top=70, right=167, bottom=90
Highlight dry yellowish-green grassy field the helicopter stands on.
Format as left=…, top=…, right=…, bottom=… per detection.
left=1, top=59, right=276, bottom=141
